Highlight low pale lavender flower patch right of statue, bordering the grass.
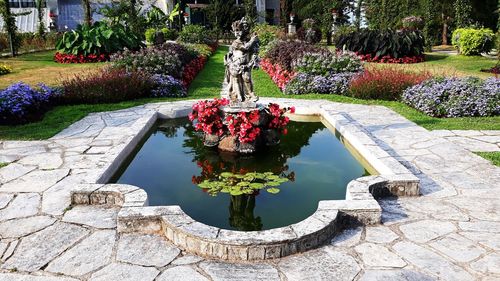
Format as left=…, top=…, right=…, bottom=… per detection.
left=283, top=73, right=353, bottom=95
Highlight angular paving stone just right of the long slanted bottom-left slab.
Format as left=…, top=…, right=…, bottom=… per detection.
left=45, top=230, right=116, bottom=276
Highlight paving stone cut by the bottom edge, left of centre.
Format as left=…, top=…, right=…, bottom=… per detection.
left=89, top=263, right=160, bottom=281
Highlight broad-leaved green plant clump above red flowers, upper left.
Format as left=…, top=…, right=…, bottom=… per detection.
left=56, top=22, right=141, bottom=56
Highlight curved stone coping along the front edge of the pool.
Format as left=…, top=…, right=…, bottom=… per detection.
left=71, top=173, right=418, bottom=260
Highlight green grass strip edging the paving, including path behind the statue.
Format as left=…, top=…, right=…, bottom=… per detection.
left=0, top=47, right=500, bottom=140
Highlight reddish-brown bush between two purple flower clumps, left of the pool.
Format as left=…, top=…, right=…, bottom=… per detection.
left=61, top=69, right=154, bottom=104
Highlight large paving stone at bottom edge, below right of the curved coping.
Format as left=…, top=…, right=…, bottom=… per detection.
left=278, top=246, right=361, bottom=281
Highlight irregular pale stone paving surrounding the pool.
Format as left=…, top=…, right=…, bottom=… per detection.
left=0, top=99, right=500, bottom=281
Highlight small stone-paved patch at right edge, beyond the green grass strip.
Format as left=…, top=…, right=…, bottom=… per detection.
left=432, top=130, right=500, bottom=152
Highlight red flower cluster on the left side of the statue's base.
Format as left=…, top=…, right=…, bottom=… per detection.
left=189, top=99, right=229, bottom=137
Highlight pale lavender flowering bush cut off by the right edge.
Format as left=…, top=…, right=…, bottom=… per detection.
left=403, top=77, right=500, bottom=117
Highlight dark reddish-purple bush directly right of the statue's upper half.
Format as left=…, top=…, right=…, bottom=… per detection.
left=265, top=41, right=329, bottom=71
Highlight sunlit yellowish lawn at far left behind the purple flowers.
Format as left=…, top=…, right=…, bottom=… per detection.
left=0, top=51, right=104, bottom=89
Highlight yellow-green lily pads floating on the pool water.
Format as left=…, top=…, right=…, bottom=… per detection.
left=198, top=172, right=288, bottom=196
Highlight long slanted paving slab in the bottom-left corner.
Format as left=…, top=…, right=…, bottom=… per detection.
left=2, top=222, right=89, bottom=271
